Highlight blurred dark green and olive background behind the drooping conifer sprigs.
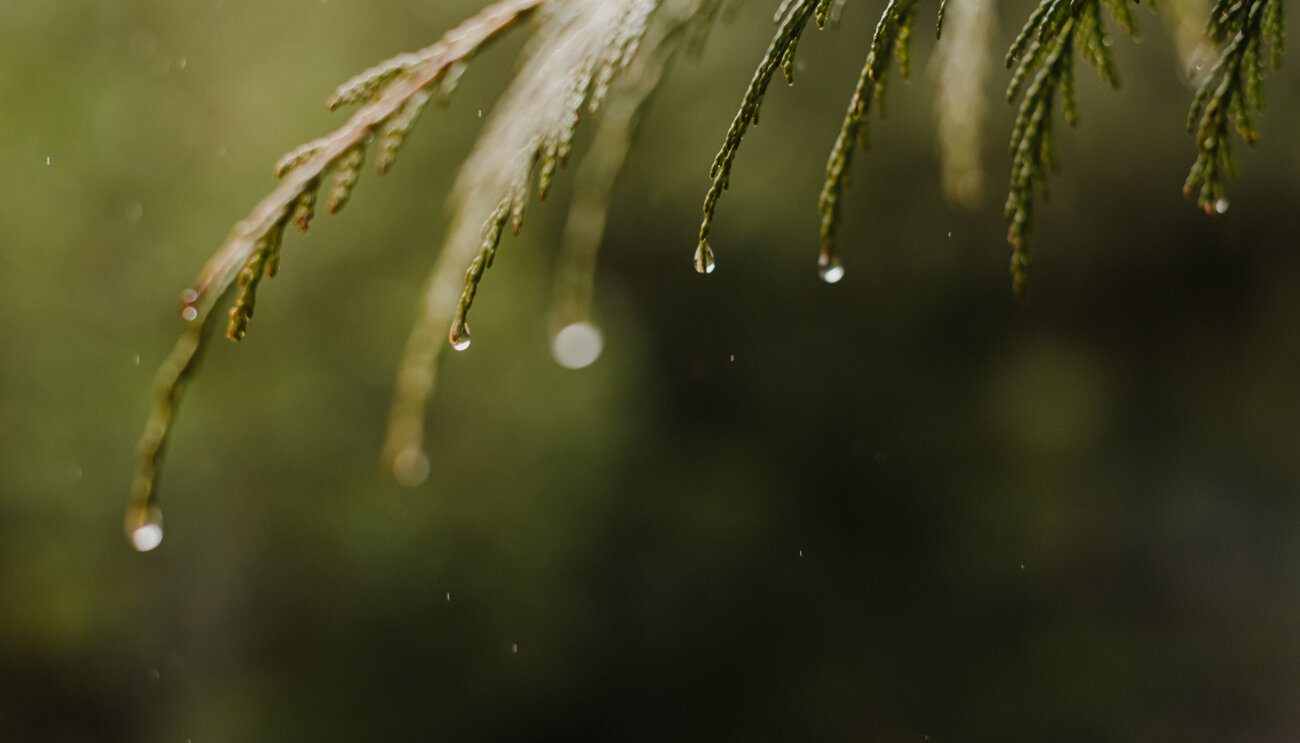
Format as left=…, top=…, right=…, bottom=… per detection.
left=0, top=0, right=1300, bottom=743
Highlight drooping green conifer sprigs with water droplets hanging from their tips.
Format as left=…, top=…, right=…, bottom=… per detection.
left=126, top=0, right=1284, bottom=549
